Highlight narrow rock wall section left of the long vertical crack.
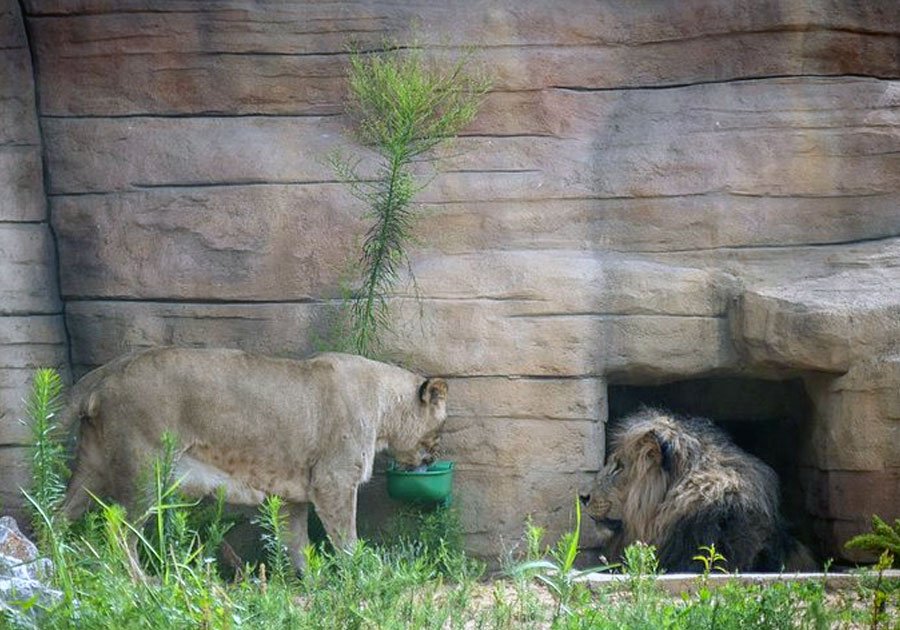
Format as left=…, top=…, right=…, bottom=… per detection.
left=0, top=0, right=67, bottom=516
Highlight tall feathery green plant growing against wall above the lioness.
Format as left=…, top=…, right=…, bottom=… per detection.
left=331, top=43, right=489, bottom=356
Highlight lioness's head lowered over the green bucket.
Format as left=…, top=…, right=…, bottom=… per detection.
left=389, top=378, right=447, bottom=467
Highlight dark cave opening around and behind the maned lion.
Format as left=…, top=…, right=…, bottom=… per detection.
left=607, top=378, right=816, bottom=549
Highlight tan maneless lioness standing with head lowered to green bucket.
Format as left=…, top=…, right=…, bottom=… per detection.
left=64, top=348, right=447, bottom=567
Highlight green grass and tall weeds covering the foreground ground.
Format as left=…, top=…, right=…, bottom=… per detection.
left=0, top=368, right=900, bottom=630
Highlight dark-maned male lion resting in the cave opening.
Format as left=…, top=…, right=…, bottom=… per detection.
left=582, top=409, right=815, bottom=571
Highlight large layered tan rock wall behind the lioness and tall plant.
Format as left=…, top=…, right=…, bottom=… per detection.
left=5, top=0, right=900, bottom=555
